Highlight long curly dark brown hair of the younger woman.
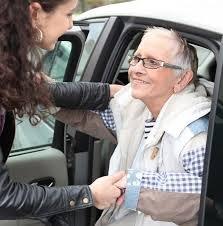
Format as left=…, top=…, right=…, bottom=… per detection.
left=0, top=0, right=67, bottom=124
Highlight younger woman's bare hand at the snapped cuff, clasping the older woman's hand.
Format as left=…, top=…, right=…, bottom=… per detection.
left=89, top=171, right=125, bottom=209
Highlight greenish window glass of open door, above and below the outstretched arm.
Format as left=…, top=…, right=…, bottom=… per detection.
left=12, top=41, right=72, bottom=152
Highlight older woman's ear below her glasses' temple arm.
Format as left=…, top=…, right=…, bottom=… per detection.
left=173, top=70, right=193, bottom=93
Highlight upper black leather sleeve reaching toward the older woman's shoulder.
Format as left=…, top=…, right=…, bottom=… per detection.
left=49, top=82, right=110, bottom=110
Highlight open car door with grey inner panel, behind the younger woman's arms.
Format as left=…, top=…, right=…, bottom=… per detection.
left=0, top=24, right=88, bottom=226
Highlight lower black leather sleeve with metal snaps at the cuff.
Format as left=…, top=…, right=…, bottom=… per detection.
left=0, top=164, right=93, bottom=220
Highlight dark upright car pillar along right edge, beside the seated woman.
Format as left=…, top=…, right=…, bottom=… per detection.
left=199, top=36, right=223, bottom=226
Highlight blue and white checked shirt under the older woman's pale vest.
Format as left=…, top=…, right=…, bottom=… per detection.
left=97, top=108, right=205, bottom=193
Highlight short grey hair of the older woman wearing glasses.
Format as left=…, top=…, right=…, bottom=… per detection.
left=142, top=27, right=198, bottom=80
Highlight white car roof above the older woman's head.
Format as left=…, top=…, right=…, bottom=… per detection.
left=76, top=0, right=223, bottom=34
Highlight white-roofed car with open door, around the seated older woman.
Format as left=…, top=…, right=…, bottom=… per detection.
left=0, top=0, right=223, bottom=226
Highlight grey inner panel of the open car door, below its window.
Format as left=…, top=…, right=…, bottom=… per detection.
left=0, top=148, right=68, bottom=226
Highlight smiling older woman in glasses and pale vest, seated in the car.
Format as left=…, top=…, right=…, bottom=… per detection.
left=58, top=28, right=211, bottom=226
